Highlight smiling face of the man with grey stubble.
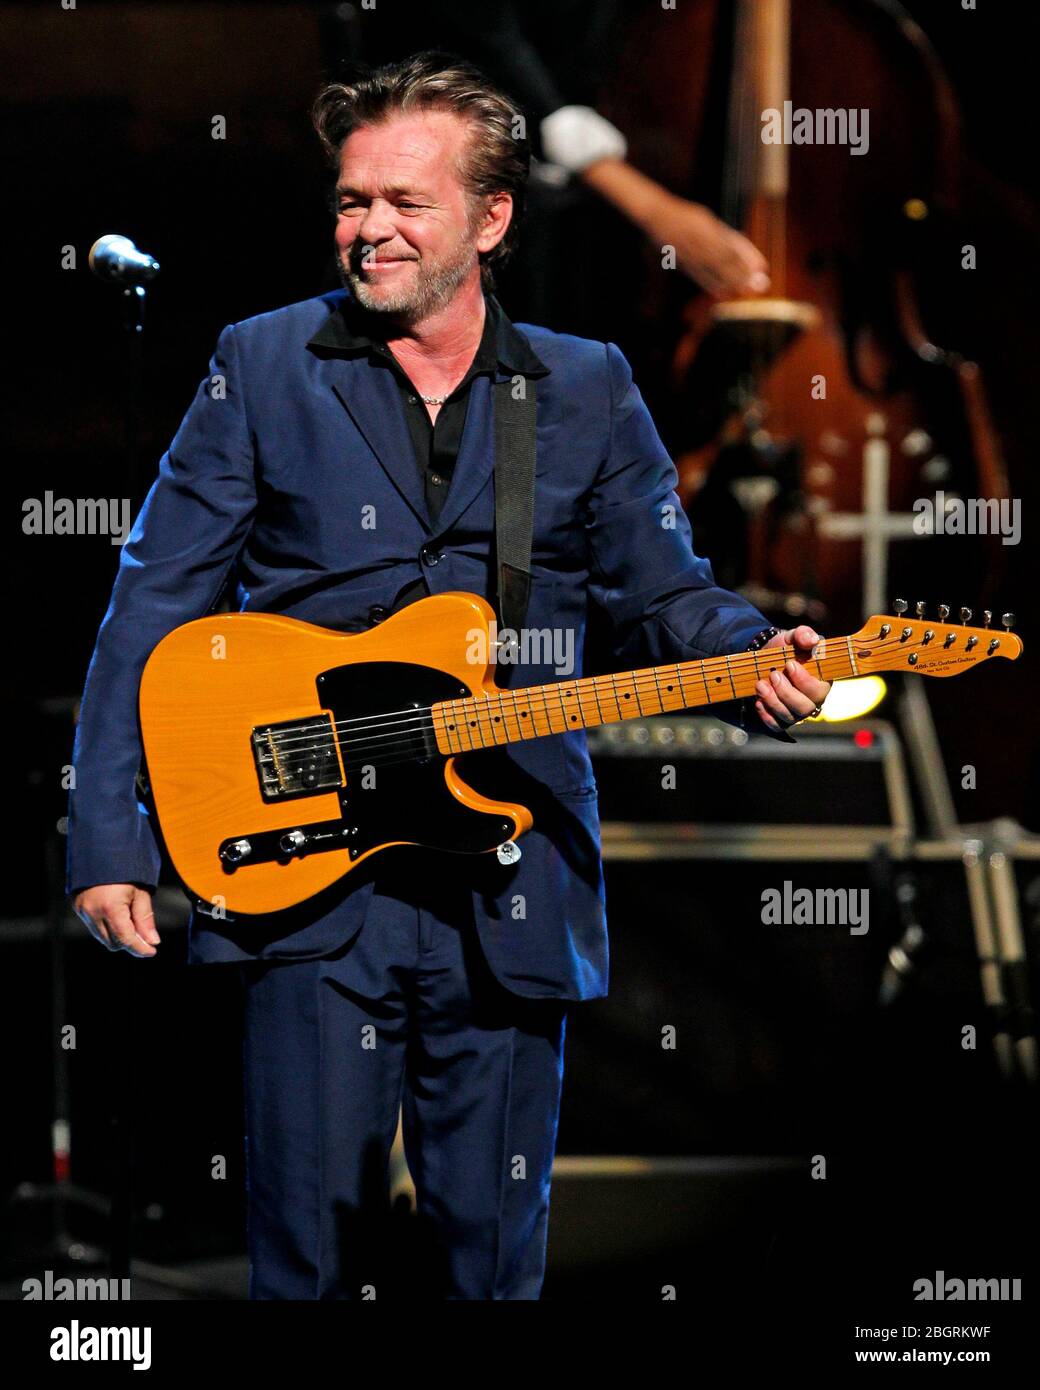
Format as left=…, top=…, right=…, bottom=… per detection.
left=335, top=110, right=512, bottom=322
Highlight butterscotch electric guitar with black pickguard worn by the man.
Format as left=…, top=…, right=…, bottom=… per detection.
left=139, top=592, right=1022, bottom=915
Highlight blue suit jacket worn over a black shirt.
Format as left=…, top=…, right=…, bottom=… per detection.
left=67, top=291, right=766, bottom=999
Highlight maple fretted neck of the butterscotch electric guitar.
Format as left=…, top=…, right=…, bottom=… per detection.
left=434, top=637, right=858, bottom=753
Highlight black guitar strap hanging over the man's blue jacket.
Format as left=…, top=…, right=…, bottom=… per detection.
left=494, top=377, right=538, bottom=632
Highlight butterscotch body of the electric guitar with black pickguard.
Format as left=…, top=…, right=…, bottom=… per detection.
left=140, top=594, right=533, bottom=915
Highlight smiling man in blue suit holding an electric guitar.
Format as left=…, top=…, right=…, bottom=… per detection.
left=68, top=54, right=829, bottom=1300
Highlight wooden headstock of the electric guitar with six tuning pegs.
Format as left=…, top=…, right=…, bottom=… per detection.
left=850, top=599, right=1022, bottom=676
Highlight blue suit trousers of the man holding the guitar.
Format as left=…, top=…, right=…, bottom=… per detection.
left=238, top=849, right=567, bottom=1300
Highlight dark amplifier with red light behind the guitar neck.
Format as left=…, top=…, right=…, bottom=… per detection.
left=588, top=714, right=912, bottom=834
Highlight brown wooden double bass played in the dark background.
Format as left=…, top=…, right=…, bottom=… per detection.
left=605, top=0, right=1008, bottom=624
